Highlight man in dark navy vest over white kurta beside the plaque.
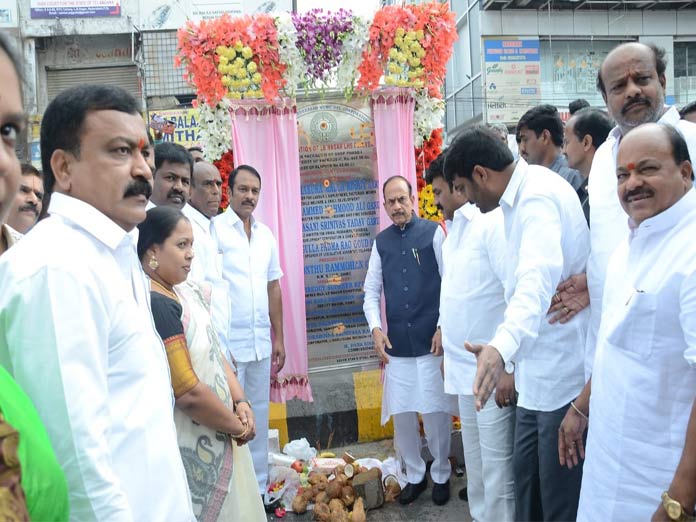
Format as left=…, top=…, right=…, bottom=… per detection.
left=363, top=176, right=457, bottom=505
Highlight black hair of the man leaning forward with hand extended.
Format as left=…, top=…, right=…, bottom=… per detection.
left=444, top=125, right=515, bottom=185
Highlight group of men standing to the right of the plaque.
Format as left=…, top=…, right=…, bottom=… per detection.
left=364, top=43, right=696, bottom=521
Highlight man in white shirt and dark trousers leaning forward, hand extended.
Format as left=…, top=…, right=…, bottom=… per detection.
left=445, top=127, right=589, bottom=520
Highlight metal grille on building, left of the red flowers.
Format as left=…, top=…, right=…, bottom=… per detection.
left=143, top=31, right=195, bottom=96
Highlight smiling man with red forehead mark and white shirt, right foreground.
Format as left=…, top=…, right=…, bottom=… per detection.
left=559, top=124, right=696, bottom=521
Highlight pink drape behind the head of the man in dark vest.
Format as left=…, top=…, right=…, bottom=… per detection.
left=372, top=87, right=418, bottom=230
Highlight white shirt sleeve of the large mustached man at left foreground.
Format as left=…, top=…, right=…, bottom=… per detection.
left=3, top=269, right=133, bottom=521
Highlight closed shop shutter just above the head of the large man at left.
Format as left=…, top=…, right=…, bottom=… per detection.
left=46, top=65, right=141, bottom=102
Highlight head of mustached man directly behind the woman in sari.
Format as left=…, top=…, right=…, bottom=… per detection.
left=148, top=141, right=193, bottom=210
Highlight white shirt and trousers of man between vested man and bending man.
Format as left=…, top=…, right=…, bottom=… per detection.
left=440, top=203, right=515, bottom=522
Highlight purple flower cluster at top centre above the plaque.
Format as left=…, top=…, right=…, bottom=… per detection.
left=292, top=9, right=353, bottom=88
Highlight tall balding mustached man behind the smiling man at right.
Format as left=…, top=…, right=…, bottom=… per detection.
left=586, top=42, right=696, bottom=373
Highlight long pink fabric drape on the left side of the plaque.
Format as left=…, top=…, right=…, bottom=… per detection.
left=231, top=100, right=313, bottom=402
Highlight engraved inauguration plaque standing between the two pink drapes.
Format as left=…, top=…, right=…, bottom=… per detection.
left=297, top=98, right=380, bottom=370
